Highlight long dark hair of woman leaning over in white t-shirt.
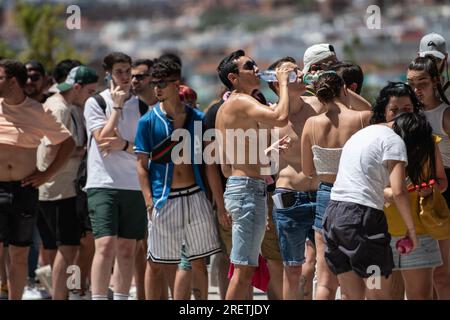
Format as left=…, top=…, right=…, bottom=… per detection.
left=392, top=112, right=436, bottom=185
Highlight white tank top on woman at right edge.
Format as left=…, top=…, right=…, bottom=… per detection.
left=424, top=103, right=450, bottom=168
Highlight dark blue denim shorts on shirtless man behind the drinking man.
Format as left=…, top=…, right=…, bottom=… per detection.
left=273, top=189, right=316, bottom=266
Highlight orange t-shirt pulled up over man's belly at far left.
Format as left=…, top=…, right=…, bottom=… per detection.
left=0, top=97, right=71, bottom=149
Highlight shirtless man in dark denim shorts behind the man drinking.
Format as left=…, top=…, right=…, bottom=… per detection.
left=269, top=57, right=324, bottom=300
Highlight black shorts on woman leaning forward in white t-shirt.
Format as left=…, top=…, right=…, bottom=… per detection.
left=323, top=200, right=394, bottom=278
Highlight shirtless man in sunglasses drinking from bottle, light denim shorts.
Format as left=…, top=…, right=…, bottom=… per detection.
left=216, top=50, right=289, bottom=299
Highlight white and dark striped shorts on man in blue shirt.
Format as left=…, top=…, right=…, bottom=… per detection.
left=147, top=186, right=221, bottom=264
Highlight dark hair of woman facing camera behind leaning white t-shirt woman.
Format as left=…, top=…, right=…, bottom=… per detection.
left=370, top=82, right=424, bottom=124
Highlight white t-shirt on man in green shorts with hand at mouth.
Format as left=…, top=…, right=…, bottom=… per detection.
left=84, top=89, right=141, bottom=190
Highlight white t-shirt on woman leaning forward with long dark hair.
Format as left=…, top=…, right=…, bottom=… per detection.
left=330, top=125, right=408, bottom=210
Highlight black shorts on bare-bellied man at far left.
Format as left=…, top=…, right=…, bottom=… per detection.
left=0, top=181, right=39, bottom=247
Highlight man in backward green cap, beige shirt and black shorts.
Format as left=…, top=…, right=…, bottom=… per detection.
left=37, top=66, right=98, bottom=300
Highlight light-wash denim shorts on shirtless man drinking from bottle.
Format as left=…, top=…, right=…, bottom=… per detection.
left=223, top=177, right=267, bottom=266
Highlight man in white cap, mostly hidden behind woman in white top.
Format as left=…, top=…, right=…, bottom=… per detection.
left=302, top=43, right=372, bottom=111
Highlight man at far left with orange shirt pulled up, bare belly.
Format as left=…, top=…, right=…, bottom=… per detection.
left=0, top=59, right=75, bottom=300
